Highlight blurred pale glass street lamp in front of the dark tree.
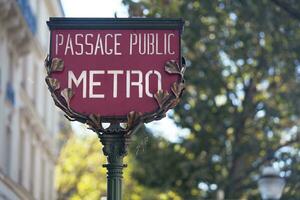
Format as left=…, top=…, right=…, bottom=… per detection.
left=258, top=166, right=285, bottom=200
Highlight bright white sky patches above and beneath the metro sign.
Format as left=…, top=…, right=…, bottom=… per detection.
left=62, top=0, right=189, bottom=142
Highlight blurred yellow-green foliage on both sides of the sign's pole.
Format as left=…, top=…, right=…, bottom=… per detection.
left=55, top=131, right=181, bottom=200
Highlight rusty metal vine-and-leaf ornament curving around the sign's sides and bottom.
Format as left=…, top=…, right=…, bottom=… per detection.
left=45, top=56, right=186, bottom=136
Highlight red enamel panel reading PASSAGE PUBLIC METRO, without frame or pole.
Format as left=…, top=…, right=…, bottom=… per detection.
left=48, top=18, right=182, bottom=121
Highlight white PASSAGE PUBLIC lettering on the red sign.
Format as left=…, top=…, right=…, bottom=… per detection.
left=53, top=32, right=176, bottom=56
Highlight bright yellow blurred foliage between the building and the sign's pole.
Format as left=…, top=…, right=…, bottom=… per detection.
left=56, top=135, right=106, bottom=200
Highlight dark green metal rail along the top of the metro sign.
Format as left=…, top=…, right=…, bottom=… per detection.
left=47, top=17, right=184, bottom=32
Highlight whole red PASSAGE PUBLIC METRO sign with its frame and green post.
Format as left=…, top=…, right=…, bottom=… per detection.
left=45, top=18, right=185, bottom=200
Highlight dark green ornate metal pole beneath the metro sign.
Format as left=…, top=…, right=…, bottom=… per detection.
left=99, top=124, right=130, bottom=200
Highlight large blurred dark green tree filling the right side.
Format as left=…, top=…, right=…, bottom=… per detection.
left=123, top=0, right=300, bottom=200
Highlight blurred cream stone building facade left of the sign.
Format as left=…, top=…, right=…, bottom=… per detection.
left=0, top=0, right=63, bottom=200
